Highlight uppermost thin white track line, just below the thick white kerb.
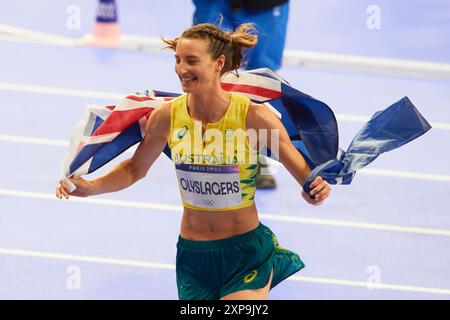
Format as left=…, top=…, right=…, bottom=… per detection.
left=0, top=82, right=450, bottom=130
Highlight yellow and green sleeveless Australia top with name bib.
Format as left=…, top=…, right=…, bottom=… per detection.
left=168, top=93, right=258, bottom=211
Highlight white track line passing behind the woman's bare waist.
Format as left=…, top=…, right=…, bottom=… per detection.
left=0, top=189, right=450, bottom=237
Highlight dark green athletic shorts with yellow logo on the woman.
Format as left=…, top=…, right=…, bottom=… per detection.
left=176, top=223, right=305, bottom=300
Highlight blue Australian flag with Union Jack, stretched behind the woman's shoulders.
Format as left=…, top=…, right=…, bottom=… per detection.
left=62, top=69, right=431, bottom=191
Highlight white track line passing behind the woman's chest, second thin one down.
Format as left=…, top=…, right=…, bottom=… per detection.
left=0, top=134, right=450, bottom=182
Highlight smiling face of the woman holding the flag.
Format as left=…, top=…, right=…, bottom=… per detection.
left=175, top=38, right=224, bottom=93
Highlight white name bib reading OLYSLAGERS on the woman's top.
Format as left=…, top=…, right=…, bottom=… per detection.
left=175, top=164, right=242, bottom=209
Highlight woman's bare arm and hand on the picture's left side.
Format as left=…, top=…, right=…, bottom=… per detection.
left=56, top=104, right=170, bottom=199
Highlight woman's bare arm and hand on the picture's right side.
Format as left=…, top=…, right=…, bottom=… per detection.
left=246, top=103, right=331, bottom=205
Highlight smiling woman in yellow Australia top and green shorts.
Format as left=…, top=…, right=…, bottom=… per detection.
left=56, top=24, right=330, bottom=299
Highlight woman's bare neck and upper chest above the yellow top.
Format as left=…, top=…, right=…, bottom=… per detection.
left=187, top=89, right=231, bottom=123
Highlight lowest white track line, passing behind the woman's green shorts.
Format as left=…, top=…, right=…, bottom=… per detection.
left=0, top=248, right=450, bottom=295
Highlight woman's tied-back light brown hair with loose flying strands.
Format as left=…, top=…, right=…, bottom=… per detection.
left=162, top=23, right=258, bottom=75
